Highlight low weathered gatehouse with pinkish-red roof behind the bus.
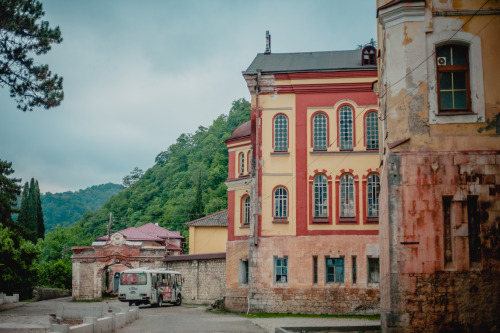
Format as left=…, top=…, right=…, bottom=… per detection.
left=71, top=223, right=184, bottom=300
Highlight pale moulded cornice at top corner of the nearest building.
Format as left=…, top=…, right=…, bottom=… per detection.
left=378, top=1, right=425, bottom=28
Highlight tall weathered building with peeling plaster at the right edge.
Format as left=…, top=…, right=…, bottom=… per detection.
left=377, top=0, right=500, bottom=332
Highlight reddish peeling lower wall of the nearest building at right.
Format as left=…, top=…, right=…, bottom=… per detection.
left=380, top=151, right=500, bottom=332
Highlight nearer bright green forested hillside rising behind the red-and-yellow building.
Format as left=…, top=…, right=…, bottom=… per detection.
left=75, top=99, right=250, bottom=239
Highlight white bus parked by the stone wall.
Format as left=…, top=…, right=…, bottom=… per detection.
left=118, top=268, right=183, bottom=306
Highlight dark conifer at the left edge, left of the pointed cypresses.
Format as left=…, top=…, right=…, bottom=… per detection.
left=0, top=160, right=21, bottom=225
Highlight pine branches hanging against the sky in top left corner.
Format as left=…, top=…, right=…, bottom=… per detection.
left=0, top=0, right=64, bottom=111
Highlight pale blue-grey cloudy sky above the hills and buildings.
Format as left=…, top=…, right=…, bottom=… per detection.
left=0, top=0, right=376, bottom=193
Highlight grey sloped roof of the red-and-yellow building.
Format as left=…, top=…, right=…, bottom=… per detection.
left=244, top=50, right=377, bottom=74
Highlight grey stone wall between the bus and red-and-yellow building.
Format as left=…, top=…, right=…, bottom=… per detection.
left=166, top=259, right=226, bottom=304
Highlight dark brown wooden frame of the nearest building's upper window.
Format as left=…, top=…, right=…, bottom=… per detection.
left=435, top=43, right=472, bottom=116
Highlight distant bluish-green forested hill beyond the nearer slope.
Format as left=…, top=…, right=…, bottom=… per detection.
left=40, top=183, right=123, bottom=231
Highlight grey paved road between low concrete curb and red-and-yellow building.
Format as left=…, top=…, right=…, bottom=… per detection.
left=117, top=305, right=267, bottom=333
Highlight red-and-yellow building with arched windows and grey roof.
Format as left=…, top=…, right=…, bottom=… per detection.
left=226, top=37, right=379, bottom=313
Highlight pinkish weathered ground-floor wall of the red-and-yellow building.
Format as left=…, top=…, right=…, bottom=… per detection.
left=226, top=235, right=380, bottom=314
